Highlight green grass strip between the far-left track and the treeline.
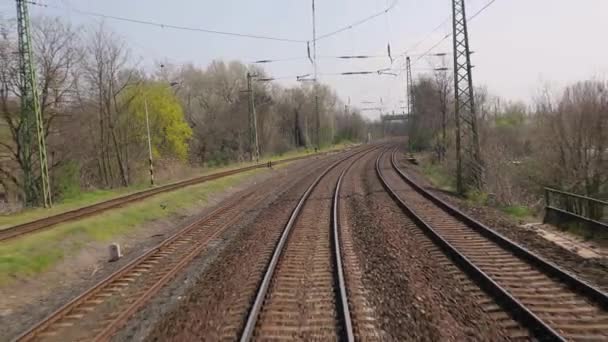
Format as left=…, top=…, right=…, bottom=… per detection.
left=0, top=143, right=352, bottom=229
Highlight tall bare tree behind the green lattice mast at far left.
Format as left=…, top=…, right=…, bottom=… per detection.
left=0, top=18, right=81, bottom=202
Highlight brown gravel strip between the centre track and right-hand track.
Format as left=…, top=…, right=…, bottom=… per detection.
left=343, top=148, right=525, bottom=341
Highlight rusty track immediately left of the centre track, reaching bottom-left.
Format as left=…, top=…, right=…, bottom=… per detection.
left=15, top=151, right=358, bottom=341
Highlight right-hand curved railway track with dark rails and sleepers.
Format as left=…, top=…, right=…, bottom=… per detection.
left=376, top=150, right=608, bottom=341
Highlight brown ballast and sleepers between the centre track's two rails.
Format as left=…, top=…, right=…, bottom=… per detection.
left=254, top=162, right=346, bottom=341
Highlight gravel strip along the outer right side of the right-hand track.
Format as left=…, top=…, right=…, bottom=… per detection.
left=398, top=154, right=608, bottom=291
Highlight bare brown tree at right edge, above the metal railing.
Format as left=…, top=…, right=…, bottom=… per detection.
left=535, top=81, right=608, bottom=196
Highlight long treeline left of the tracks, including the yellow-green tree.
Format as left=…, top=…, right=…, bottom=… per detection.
left=0, top=17, right=371, bottom=206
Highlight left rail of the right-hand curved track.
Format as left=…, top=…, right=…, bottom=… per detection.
left=376, top=149, right=566, bottom=341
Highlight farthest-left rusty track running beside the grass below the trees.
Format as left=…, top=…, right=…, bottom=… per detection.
left=0, top=150, right=342, bottom=242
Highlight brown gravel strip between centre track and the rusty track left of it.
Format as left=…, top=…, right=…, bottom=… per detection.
left=138, top=148, right=364, bottom=341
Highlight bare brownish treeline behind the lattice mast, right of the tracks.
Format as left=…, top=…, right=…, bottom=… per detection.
left=409, top=71, right=608, bottom=206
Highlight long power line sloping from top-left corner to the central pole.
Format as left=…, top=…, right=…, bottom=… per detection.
left=26, top=1, right=306, bottom=43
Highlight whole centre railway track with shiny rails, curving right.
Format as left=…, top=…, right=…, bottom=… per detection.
left=240, top=148, right=374, bottom=342
